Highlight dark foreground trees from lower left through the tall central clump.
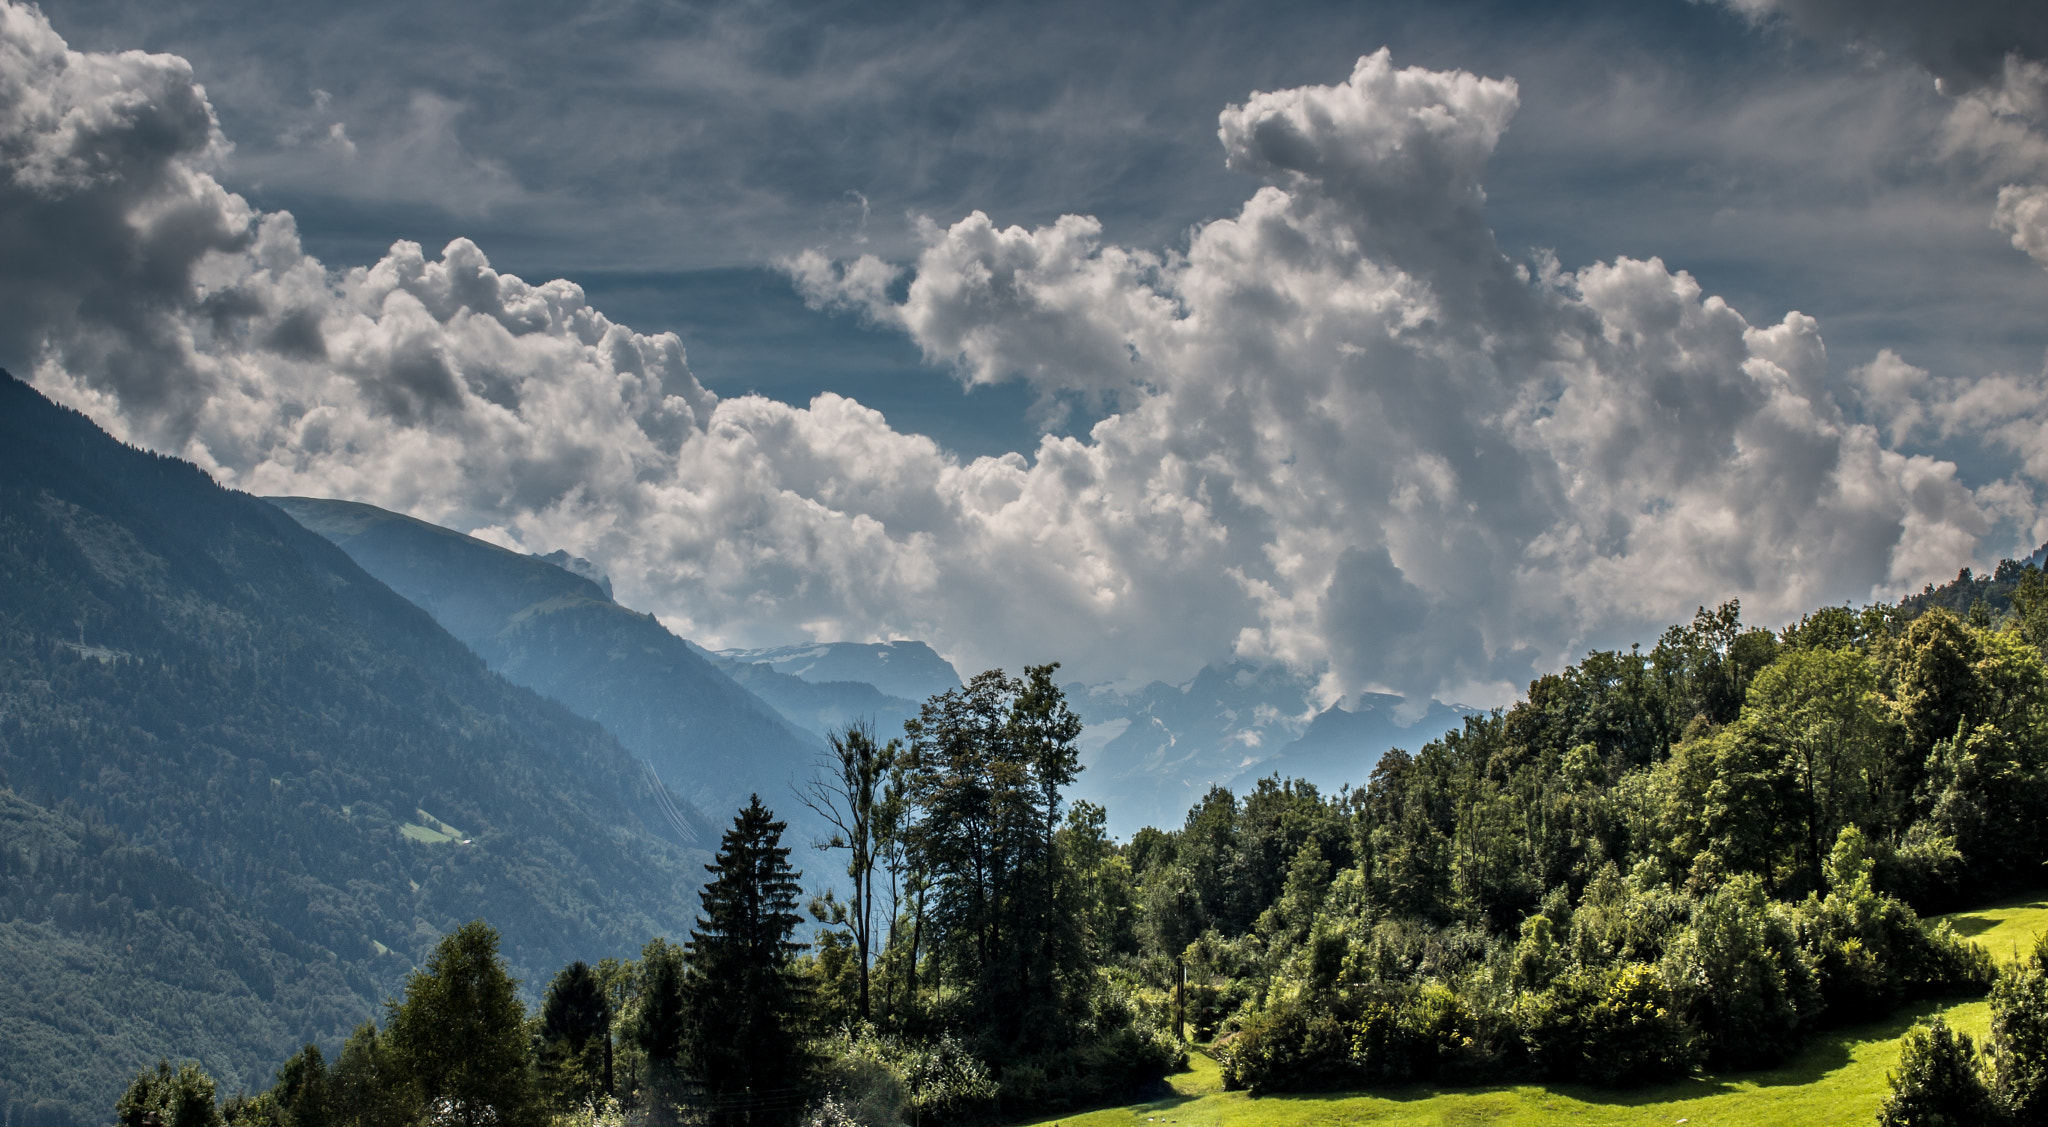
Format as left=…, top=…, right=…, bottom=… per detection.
left=119, top=664, right=1182, bottom=1127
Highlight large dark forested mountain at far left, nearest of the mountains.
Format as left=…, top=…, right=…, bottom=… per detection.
left=0, top=373, right=717, bottom=1127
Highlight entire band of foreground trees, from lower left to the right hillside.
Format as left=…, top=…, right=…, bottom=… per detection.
left=121, top=561, right=2048, bottom=1127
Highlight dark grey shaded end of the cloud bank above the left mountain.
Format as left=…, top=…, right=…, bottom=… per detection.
left=0, top=8, right=248, bottom=430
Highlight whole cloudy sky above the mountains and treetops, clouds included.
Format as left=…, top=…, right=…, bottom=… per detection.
left=0, top=0, right=2048, bottom=705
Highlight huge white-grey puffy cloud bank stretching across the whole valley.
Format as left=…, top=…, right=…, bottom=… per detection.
left=12, top=4, right=2048, bottom=699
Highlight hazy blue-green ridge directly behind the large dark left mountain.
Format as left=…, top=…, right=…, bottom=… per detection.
left=270, top=498, right=823, bottom=813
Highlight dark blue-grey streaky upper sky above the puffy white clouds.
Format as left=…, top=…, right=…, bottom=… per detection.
left=28, top=0, right=2048, bottom=420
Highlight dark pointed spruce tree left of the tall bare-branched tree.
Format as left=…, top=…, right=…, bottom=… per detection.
left=684, top=795, right=809, bottom=1127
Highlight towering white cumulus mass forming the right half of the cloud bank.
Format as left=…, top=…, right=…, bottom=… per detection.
left=797, top=51, right=1993, bottom=693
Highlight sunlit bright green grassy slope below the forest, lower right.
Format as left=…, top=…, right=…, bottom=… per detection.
left=1015, top=893, right=2048, bottom=1127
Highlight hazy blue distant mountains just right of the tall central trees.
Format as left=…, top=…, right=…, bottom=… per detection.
left=1065, top=662, right=1470, bottom=836
